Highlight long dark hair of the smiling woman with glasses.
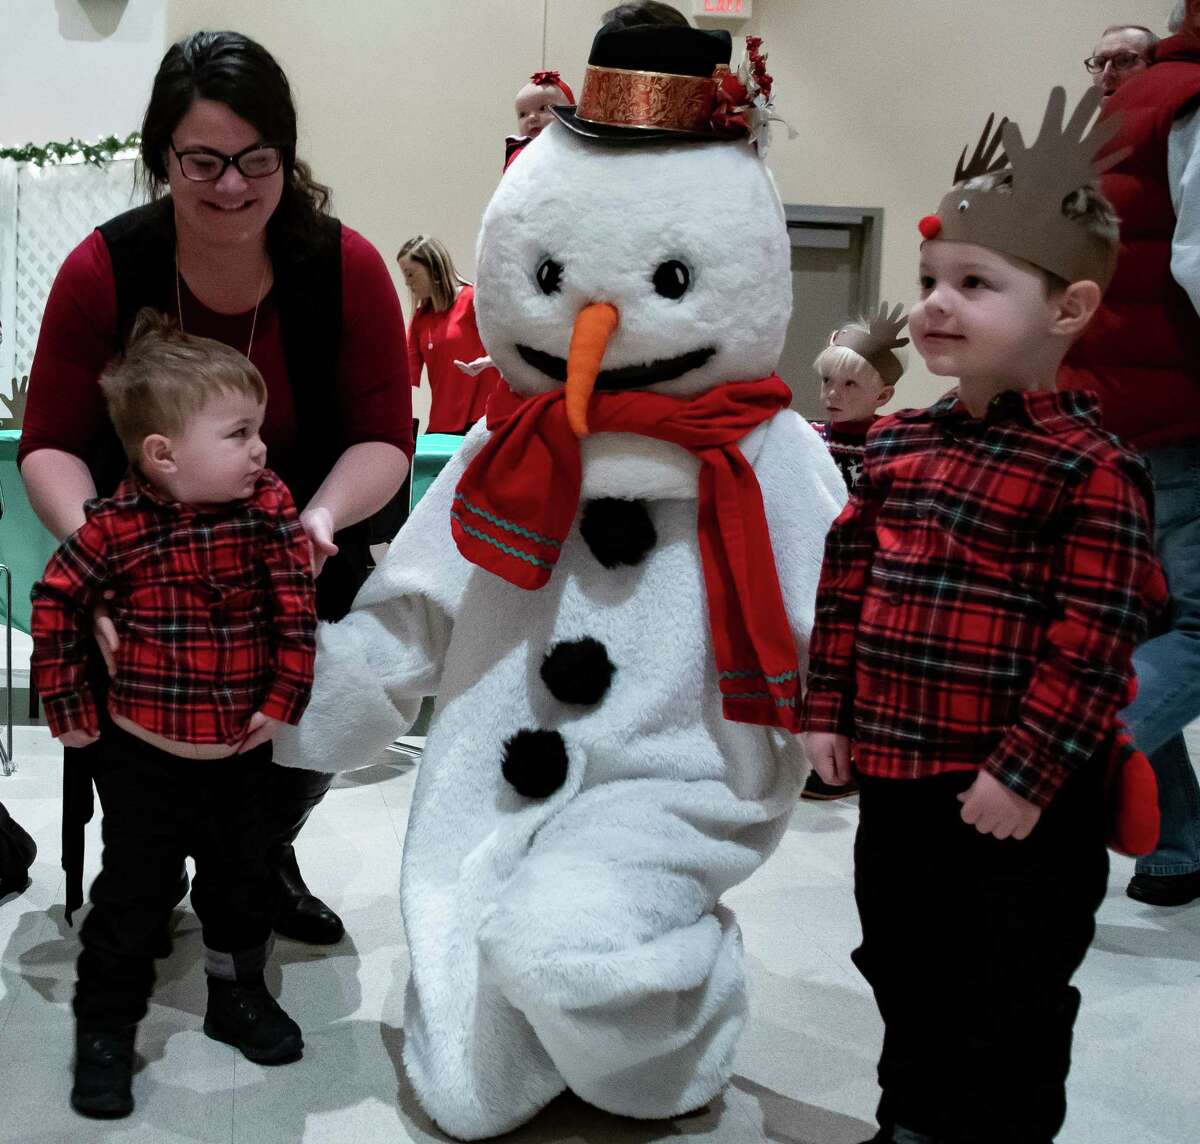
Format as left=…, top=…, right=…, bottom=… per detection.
left=142, top=31, right=330, bottom=244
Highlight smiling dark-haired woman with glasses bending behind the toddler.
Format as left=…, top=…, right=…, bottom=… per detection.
left=19, top=32, right=413, bottom=944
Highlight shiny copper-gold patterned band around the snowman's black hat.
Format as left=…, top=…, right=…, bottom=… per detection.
left=576, top=64, right=730, bottom=134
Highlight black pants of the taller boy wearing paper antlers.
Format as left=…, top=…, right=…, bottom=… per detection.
left=853, top=768, right=1108, bottom=1144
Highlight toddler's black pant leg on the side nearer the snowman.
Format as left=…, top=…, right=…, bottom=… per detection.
left=192, top=744, right=280, bottom=980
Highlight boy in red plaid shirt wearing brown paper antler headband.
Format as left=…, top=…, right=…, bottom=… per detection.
left=804, top=88, right=1164, bottom=1144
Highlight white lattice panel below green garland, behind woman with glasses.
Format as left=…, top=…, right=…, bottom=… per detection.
left=0, top=157, right=142, bottom=391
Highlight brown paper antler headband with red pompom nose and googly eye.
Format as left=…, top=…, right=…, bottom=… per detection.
left=920, top=88, right=1129, bottom=288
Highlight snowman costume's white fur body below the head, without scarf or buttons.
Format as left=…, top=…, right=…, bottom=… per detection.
left=281, top=412, right=845, bottom=1139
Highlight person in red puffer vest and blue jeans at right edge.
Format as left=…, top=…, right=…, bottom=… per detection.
left=1058, top=0, right=1200, bottom=906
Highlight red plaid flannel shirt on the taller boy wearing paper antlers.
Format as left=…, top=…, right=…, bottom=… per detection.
left=803, top=393, right=1166, bottom=807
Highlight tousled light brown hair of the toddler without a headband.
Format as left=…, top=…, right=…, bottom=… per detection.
left=100, top=307, right=266, bottom=461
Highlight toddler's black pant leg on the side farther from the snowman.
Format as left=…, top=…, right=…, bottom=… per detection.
left=74, top=726, right=188, bottom=1030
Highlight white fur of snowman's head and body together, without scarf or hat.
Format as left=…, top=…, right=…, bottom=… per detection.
left=278, top=115, right=846, bottom=1139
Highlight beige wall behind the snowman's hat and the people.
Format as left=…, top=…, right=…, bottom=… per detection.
left=167, top=0, right=1171, bottom=415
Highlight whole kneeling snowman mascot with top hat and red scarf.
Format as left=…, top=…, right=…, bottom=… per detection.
left=280, top=20, right=846, bottom=1139
